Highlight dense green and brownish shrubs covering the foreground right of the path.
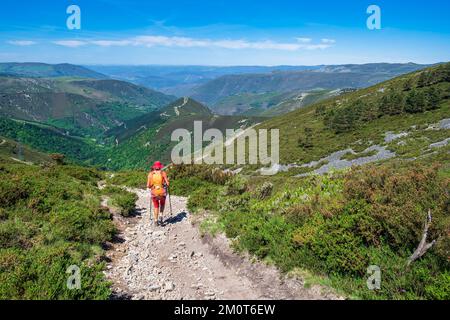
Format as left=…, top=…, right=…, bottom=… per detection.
left=188, top=162, right=450, bottom=299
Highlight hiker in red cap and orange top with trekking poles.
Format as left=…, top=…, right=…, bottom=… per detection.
left=147, top=161, right=169, bottom=226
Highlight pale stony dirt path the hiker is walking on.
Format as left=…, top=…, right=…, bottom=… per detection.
left=106, top=189, right=337, bottom=300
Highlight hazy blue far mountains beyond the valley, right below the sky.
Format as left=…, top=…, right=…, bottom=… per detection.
left=90, top=63, right=427, bottom=116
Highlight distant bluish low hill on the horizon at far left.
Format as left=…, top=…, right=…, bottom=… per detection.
left=0, top=62, right=107, bottom=79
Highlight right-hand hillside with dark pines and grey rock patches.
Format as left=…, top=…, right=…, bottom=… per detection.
left=253, top=64, right=450, bottom=174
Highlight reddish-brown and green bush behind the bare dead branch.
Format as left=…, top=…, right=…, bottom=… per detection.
left=344, top=165, right=450, bottom=254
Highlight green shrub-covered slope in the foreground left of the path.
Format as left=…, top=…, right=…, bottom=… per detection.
left=0, top=159, right=114, bottom=299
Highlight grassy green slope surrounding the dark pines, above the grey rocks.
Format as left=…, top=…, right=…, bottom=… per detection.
left=258, top=65, right=450, bottom=163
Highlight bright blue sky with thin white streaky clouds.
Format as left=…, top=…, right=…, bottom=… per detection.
left=0, top=0, right=450, bottom=65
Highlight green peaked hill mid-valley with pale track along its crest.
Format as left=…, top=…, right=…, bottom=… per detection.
left=107, top=98, right=261, bottom=169
